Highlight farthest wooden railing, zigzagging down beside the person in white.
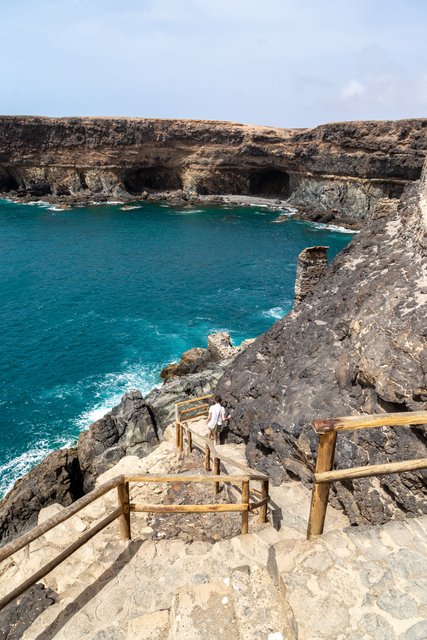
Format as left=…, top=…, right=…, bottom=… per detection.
left=175, top=395, right=269, bottom=533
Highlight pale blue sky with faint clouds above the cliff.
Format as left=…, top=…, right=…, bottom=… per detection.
left=0, top=0, right=427, bottom=127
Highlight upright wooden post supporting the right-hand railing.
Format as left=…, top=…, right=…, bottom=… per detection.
left=307, top=431, right=337, bottom=540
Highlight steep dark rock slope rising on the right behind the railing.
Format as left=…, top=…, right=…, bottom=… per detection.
left=217, top=160, right=427, bottom=523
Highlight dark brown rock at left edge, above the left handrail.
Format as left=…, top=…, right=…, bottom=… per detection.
left=0, top=449, right=83, bottom=540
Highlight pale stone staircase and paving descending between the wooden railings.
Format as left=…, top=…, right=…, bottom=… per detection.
left=0, top=422, right=427, bottom=640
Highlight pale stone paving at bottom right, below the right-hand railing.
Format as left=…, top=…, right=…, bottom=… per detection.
left=268, top=516, right=427, bottom=640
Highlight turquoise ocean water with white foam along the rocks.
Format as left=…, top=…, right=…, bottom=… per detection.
left=0, top=201, right=352, bottom=495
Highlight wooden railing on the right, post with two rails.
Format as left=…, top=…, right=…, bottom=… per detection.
left=307, top=411, right=427, bottom=539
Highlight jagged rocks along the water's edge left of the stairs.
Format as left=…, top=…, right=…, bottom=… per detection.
left=0, top=333, right=247, bottom=544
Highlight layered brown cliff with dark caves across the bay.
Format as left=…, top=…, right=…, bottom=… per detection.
left=0, top=116, right=427, bottom=220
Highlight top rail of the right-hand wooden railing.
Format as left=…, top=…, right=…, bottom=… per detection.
left=313, top=411, right=427, bottom=433
